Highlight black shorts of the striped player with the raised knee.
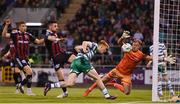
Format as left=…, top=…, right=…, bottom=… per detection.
left=53, top=53, right=72, bottom=71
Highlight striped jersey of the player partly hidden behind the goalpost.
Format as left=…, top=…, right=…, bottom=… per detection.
left=150, top=43, right=166, bottom=63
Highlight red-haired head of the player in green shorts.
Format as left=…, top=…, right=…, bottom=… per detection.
left=98, top=40, right=109, bottom=54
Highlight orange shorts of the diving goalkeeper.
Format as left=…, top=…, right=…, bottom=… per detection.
left=107, top=68, right=132, bottom=86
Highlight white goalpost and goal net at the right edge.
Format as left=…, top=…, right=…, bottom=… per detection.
left=152, top=0, right=180, bottom=102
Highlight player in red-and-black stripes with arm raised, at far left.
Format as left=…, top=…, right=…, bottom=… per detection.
left=2, top=20, right=44, bottom=95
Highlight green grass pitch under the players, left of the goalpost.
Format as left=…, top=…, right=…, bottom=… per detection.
left=0, top=86, right=151, bottom=104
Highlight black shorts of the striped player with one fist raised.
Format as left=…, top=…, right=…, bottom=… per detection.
left=15, top=58, right=31, bottom=70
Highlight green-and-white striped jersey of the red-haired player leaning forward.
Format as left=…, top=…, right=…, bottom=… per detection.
left=77, top=42, right=98, bottom=60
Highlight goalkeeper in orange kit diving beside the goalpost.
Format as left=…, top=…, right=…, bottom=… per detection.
left=83, top=31, right=175, bottom=96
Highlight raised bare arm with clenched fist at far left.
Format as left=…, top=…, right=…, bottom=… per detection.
left=2, top=19, right=11, bottom=38
